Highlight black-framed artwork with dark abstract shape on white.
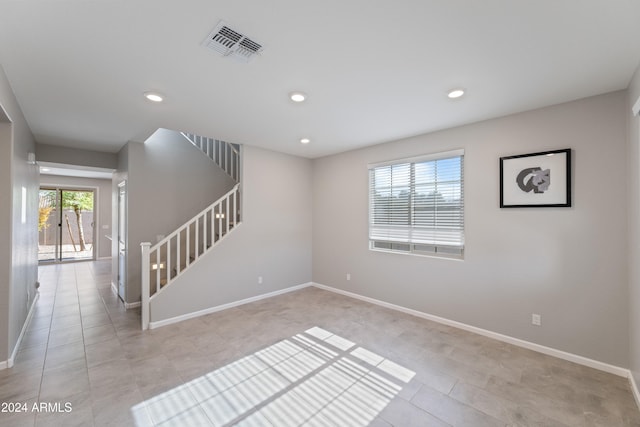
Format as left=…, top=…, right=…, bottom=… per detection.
left=500, top=148, right=571, bottom=208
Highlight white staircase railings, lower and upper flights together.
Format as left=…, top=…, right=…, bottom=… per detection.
left=141, top=133, right=241, bottom=330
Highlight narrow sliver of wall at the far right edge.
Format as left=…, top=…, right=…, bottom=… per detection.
left=625, top=67, right=640, bottom=384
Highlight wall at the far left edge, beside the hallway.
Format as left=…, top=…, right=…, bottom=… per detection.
left=0, top=67, right=38, bottom=363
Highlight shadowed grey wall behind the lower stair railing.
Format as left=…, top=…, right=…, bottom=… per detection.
left=119, top=129, right=235, bottom=303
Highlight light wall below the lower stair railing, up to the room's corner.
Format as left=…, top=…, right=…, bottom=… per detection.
left=151, top=146, right=312, bottom=322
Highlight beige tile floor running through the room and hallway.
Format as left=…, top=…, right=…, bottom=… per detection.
left=0, top=261, right=640, bottom=427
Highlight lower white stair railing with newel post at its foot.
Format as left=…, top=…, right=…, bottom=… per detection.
left=140, top=184, right=241, bottom=330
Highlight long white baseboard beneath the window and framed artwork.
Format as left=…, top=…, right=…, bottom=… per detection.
left=313, top=283, right=640, bottom=378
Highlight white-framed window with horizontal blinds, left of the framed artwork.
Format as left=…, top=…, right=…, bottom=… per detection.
left=369, top=150, right=464, bottom=257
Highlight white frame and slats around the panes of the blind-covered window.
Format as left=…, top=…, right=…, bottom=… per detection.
left=367, top=149, right=465, bottom=259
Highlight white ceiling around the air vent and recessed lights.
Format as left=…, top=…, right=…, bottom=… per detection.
left=0, top=0, right=640, bottom=158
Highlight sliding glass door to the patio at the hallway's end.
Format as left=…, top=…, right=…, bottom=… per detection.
left=38, top=187, right=95, bottom=262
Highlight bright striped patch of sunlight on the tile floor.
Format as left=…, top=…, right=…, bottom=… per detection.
left=131, top=327, right=415, bottom=427
